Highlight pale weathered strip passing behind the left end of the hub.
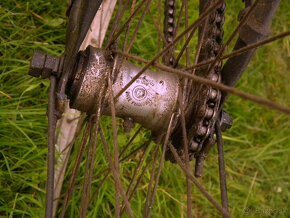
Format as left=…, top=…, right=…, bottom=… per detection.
left=53, top=0, right=116, bottom=217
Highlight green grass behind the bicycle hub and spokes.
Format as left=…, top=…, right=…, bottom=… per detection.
left=0, top=0, right=290, bottom=217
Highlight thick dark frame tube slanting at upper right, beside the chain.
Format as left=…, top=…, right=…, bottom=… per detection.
left=221, top=0, right=280, bottom=104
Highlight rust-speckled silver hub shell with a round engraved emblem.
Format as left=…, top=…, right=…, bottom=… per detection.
left=69, top=46, right=179, bottom=133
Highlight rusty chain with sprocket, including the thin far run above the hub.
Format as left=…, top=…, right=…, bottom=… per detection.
left=164, top=0, right=225, bottom=162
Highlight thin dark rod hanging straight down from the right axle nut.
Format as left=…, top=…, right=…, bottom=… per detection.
left=215, top=119, right=229, bottom=211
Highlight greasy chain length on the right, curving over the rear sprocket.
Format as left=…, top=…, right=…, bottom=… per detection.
left=189, top=3, right=225, bottom=153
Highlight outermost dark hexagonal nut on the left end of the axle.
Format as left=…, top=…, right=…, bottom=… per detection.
left=28, top=50, right=46, bottom=77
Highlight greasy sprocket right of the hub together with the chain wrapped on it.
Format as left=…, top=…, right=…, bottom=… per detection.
left=166, top=0, right=225, bottom=166
